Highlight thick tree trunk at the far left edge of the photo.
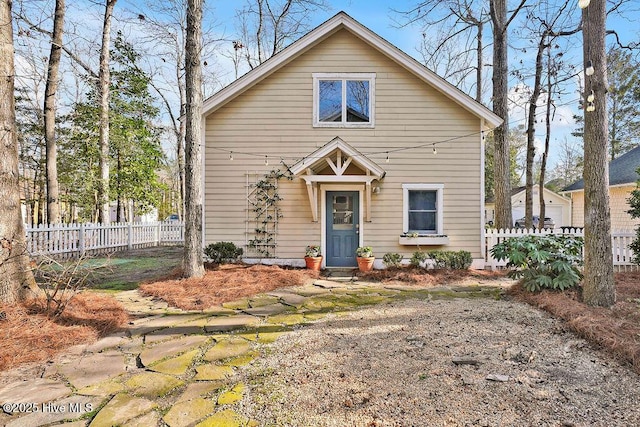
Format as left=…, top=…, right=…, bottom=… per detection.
left=0, top=0, right=38, bottom=303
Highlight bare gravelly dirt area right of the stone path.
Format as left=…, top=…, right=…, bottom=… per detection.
left=238, top=299, right=640, bottom=426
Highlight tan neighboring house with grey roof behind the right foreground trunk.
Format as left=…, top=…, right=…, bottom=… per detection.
left=562, top=147, right=640, bottom=231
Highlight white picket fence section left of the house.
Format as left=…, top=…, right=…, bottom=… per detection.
left=26, top=221, right=184, bottom=257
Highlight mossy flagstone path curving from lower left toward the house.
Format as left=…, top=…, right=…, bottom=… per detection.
left=0, top=280, right=502, bottom=427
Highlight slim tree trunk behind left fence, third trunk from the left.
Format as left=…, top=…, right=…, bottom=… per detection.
left=98, top=0, right=117, bottom=224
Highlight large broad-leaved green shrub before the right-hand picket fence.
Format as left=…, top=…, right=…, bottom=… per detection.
left=491, top=235, right=584, bottom=292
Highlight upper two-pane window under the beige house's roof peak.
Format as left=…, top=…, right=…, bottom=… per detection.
left=313, top=73, right=375, bottom=128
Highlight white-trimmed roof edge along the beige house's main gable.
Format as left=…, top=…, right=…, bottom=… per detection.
left=202, top=12, right=502, bottom=129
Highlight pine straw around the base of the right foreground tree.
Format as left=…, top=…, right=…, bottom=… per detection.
left=509, top=272, right=640, bottom=374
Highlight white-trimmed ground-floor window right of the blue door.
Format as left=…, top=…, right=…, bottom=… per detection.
left=402, top=184, right=444, bottom=235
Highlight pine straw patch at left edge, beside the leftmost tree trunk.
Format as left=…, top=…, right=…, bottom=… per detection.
left=0, top=293, right=129, bottom=371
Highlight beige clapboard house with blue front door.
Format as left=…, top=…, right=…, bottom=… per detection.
left=203, top=12, right=502, bottom=267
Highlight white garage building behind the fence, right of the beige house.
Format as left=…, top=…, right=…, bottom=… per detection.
left=485, top=184, right=571, bottom=228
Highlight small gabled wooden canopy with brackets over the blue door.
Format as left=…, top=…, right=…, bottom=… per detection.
left=290, top=137, right=386, bottom=222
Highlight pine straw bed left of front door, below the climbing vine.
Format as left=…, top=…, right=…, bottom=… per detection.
left=139, top=264, right=319, bottom=310
